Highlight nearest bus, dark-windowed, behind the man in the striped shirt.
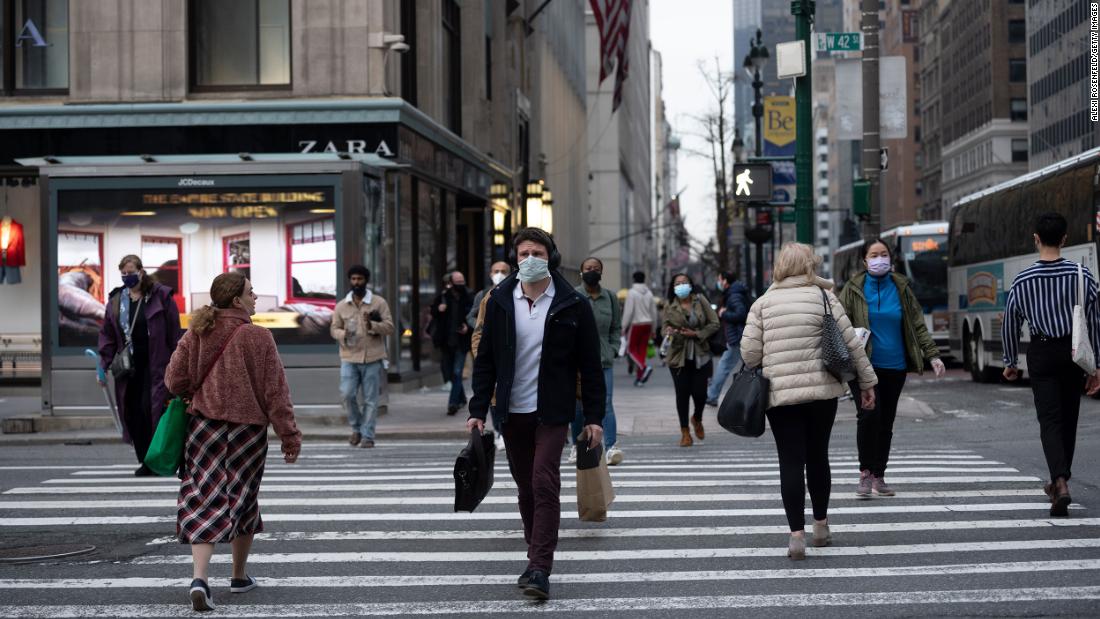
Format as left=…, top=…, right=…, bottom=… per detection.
left=947, top=147, right=1100, bottom=383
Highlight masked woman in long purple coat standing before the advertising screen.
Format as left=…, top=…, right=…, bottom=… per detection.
left=99, top=255, right=182, bottom=477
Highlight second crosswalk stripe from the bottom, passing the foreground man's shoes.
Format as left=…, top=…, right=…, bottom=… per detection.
left=8, top=559, right=1100, bottom=590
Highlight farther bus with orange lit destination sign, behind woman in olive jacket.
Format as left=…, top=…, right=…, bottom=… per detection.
left=833, top=221, right=950, bottom=358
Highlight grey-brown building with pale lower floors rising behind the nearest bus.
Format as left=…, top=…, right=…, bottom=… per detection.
left=941, top=0, right=1029, bottom=211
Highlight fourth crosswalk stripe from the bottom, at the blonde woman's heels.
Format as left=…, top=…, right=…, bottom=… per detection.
left=135, top=518, right=1100, bottom=545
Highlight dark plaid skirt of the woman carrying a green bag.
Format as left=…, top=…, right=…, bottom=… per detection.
left=176, top=414, right=267, bottom=544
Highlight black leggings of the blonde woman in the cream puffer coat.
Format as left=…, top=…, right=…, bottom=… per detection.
left=768, top=398, right=836, bottom=531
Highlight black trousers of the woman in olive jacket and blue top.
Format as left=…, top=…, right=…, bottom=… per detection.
left=848, top=367, right=906, bottom=477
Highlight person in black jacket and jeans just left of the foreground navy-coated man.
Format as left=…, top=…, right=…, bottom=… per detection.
left=431, top=270, right=473, bottom=414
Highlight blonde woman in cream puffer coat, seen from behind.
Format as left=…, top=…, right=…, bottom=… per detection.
left=741, top=243, right=878, bottom=560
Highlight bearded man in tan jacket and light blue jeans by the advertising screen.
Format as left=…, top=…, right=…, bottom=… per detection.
left=329, top=265, right=394, bottom=447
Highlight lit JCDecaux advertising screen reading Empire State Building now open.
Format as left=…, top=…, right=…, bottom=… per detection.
left=56, top=179, right=340, bottom=347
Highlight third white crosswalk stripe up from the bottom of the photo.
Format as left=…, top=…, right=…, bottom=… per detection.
left=128, top=538, right=1100, bottom=565
